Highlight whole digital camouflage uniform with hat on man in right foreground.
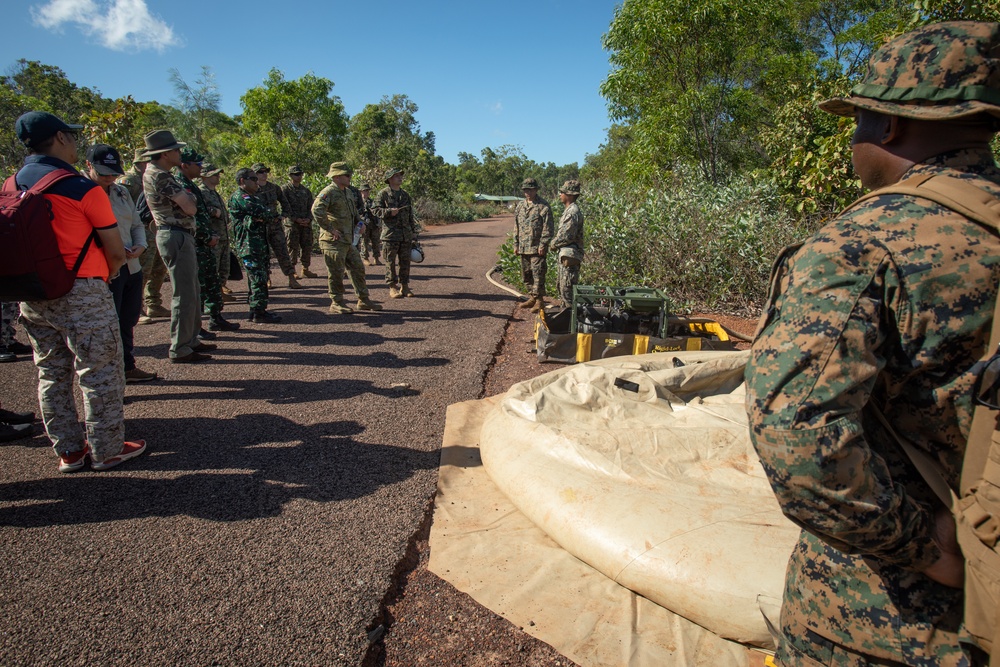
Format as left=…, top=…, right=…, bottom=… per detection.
left=746, top=23, right=1000, bottom=666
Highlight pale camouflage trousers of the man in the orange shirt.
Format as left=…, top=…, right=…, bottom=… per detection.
left=21, top=278, right=125, bottom=461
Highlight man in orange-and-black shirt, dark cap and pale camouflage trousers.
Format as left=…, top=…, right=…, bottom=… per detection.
left=14, top=111, right=146, bottom=472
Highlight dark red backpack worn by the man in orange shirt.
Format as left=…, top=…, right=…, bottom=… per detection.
left=0, top=169, right=97, bottom=301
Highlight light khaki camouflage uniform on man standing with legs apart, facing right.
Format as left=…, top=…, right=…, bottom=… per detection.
left=312, top=171, right=368, bottom=306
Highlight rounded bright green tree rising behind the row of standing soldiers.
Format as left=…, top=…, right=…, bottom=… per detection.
left=240, top=69, right=347, bottom=174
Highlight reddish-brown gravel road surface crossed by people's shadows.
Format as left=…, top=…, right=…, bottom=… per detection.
left=0, top=217, right=513, bottom=666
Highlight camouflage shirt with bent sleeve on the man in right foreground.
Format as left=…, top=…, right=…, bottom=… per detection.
left=746, top=177, right=1000, bottom=570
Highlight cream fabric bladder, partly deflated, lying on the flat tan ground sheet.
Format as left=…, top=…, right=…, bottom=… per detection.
left=480, top=352, right=799, bottom=647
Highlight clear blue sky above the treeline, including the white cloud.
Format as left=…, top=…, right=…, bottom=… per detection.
left=0, top=0, right=621, bottom=165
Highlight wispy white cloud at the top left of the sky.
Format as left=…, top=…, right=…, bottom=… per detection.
left=32, top=0, right=178, bottom=51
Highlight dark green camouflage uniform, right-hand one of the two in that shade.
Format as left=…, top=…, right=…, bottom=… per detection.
left=229, top=188, right=274, bottom=312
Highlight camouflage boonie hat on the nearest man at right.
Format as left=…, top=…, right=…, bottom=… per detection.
left=819, top=21, right=1000, bottom=120
